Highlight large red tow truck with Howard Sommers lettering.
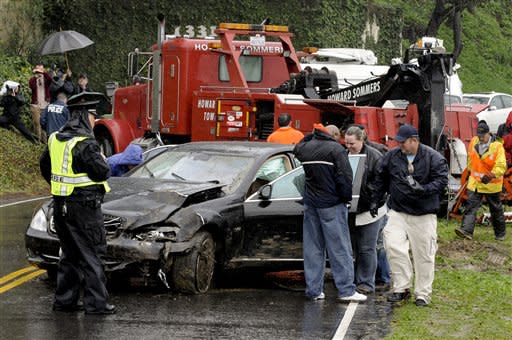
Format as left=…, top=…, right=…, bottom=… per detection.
left=94, top=16, right=479, bottom=178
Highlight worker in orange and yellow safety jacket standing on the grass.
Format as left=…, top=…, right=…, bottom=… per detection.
left=455, top=121, right=507, bottom=241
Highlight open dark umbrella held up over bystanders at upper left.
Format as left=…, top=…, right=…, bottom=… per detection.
left=39, top=31, right=94, bottom=68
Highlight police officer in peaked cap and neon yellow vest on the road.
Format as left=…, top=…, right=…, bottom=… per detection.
left=40, top=92, right=116, bottom=314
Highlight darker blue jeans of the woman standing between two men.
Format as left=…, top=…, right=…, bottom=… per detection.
left=350, top=219, right=381, bottom=291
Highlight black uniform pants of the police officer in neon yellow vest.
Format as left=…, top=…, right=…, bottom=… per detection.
left=54, top=197, right=108, bottom=311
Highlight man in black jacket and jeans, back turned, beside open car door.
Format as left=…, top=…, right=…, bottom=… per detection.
left=294, top=124, right=366, bottom=301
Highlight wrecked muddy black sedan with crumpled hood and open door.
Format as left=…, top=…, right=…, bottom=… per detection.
left=25, top=142, right=364, bottom=293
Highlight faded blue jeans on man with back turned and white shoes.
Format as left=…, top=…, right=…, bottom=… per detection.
left=303, top=204, right=355, bottom=297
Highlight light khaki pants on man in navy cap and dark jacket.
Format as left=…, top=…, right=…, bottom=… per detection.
left=383, top=210, right=437, bottom=302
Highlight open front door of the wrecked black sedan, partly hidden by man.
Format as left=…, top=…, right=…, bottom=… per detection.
left=240, top=155, right=366, bottom=261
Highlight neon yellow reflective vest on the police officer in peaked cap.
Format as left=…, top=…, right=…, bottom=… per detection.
left=48, top=132, right=110, bottom=196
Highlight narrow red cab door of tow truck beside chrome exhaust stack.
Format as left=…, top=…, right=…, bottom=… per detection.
left=160, top=55, right=183, bottom=134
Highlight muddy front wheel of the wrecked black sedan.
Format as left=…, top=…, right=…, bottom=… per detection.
left=172, top=231, right=215, bottom=294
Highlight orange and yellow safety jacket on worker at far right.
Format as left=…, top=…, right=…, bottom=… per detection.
left=468, top=137, right=507, bottom=194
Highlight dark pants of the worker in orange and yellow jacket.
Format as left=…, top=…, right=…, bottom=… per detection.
left=462, top=190, right=506, bottom=237
